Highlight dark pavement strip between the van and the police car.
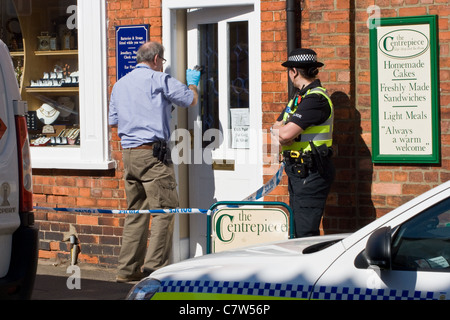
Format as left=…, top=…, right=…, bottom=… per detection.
left=32, top=260, right=136, bottom=300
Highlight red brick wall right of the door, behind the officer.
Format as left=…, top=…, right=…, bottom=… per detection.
left=261, top=0, right=450, bottom=233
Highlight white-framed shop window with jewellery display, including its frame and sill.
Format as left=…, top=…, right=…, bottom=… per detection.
left=0, top=0, right=113, bottom=169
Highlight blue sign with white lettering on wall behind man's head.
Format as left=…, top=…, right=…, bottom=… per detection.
left=116, top=25, right=150, bottom=80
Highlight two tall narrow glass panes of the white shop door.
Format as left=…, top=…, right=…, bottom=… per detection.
left=199, top=21, right=250, bottom=149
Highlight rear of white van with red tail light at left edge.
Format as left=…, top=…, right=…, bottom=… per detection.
left=0, top=40, right=38, bottom=300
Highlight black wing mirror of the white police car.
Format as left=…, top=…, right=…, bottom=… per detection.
left=364, top=227, right=391, bottom=269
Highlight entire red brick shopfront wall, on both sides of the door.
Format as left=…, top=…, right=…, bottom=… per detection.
left=33, top=0, right=450, bottom=266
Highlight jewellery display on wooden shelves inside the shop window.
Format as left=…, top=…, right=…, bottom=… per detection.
left=0, top=0, right=81, bottom=148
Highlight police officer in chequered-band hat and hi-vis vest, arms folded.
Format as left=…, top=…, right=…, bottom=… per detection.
left=272, top=48, right=334, bottom=238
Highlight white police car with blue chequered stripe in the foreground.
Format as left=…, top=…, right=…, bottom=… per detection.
left=127, top=181, right=450, bottom=300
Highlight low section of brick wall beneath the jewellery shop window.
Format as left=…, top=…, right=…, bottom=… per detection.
left=33, top=170, right=126, bottom=265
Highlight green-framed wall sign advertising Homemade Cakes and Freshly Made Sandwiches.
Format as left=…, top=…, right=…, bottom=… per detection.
left=370, top=16, right=440, bottom=163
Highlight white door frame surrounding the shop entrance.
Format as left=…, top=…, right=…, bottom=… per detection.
left=162, top=0, right=263, bottom=262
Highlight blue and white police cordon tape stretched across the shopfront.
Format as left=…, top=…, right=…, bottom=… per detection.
left=33, top=163, right=284, bottom=214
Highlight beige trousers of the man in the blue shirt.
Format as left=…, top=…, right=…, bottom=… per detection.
left=118, top=149, right=178, bottom=277
